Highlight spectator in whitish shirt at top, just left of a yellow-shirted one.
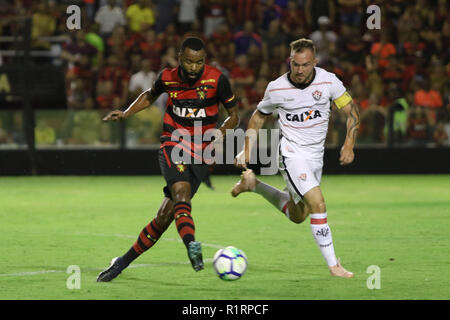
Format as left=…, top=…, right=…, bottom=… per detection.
left=95, top=0, right=126, bottom=39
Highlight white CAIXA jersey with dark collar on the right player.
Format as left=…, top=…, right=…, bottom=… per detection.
left=257, top=67, right=351, bottom=159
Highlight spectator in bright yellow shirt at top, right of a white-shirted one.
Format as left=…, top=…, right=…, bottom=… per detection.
left=126, top=0, right=155, bottom=32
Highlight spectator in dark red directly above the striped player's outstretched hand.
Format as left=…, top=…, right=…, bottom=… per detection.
left=96, top=55, right=130, bottom=109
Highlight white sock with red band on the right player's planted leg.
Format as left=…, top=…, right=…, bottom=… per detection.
left=310, top=212, right=337, bottom=267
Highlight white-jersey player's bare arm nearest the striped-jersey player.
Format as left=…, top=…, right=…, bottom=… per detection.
left=234, top=109, right=267, bottom=169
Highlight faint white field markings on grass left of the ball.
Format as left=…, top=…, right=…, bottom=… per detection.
left=0, top=233, right=225, bottom=277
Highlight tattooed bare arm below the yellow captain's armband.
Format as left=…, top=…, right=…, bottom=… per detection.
left=339, top=101, right=359, bottom=165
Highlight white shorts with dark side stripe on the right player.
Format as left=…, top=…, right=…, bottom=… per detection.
left=278, top=154, right=323, bottom=204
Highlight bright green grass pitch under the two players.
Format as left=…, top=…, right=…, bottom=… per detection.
left=0, top=175, right=450, bottom=300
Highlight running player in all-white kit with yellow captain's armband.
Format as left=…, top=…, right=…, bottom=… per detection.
left=231, top=39, right=359, bottom=278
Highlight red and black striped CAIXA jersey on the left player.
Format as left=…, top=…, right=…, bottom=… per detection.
left=151, top=65, right=237, bottom=159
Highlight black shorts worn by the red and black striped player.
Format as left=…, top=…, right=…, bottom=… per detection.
left=158, top=147, right=208, bottom=199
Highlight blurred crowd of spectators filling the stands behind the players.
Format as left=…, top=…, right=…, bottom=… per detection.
left=0, top=0, right=450, bottom=146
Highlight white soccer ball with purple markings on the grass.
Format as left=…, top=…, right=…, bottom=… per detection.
left=213, top=246, right=247, bottom=280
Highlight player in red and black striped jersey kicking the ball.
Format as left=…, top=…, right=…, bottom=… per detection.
left=97, top=37, right=239, bottom=282
